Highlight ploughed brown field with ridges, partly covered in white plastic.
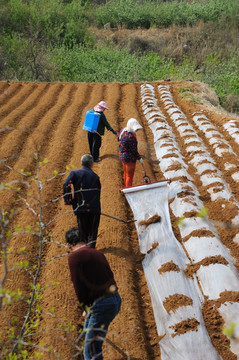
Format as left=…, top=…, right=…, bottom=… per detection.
left=0, top=80, right=239, bottom=360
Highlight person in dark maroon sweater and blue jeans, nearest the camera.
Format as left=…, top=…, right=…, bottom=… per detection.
left=65, top=227, right=121, bottom=360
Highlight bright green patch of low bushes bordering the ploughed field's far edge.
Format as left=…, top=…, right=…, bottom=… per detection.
left=55, top=46, right=174, bottom=82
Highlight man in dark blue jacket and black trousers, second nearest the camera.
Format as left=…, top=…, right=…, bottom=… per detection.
left=63, top=154, right=101, bottom=248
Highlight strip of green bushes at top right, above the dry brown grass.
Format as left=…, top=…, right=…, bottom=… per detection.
left=95, top=0, right=239, bottom=29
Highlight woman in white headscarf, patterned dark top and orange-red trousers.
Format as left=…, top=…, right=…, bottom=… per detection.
left=118, top=118, right=143, bottom=187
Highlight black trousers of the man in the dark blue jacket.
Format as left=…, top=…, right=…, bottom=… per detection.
left=77, top=213, right=100, bottom=248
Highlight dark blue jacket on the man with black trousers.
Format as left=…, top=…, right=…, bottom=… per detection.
left=63, top=166, right=101, bottom=215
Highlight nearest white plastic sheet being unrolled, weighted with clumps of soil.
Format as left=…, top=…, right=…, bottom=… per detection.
left=122, top=181, right=221, bottom=360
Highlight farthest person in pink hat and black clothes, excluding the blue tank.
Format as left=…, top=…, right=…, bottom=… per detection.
left=88, top=101, right=117, bottom=162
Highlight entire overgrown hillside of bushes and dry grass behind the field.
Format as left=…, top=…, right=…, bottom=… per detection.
left=0, top=0, right=239, bottom=112
